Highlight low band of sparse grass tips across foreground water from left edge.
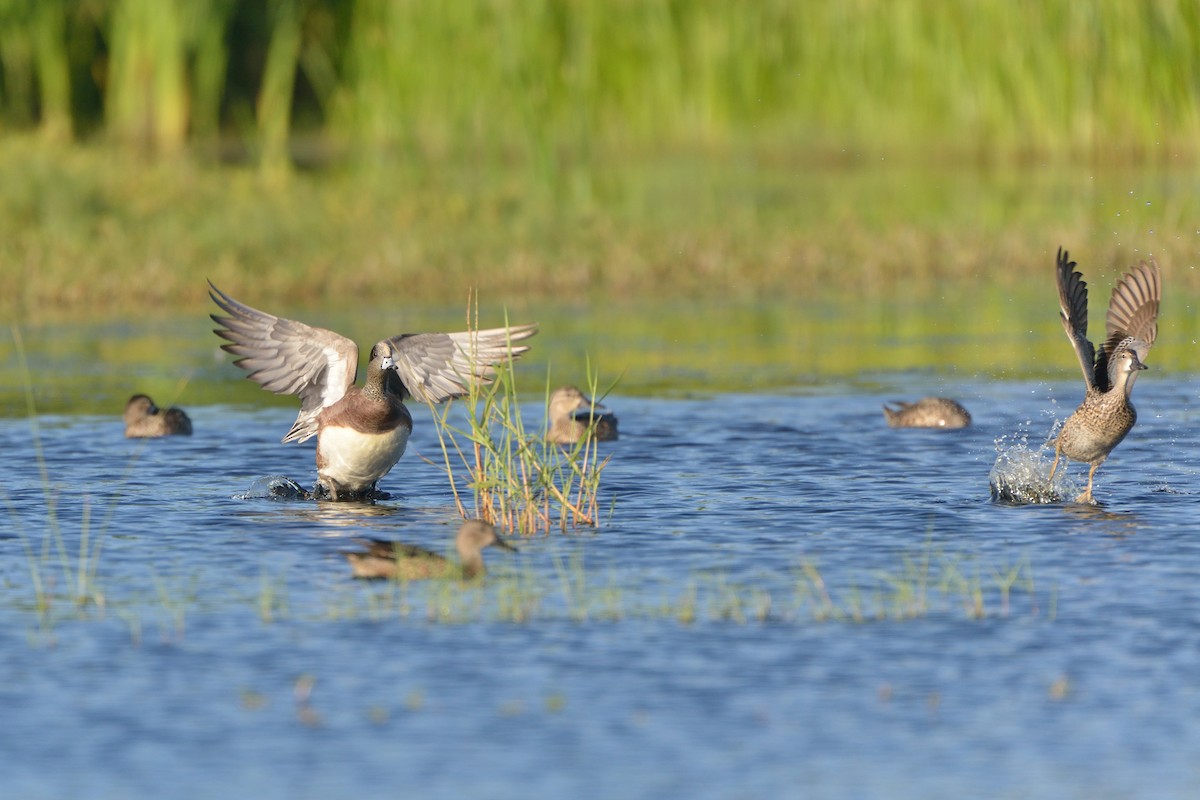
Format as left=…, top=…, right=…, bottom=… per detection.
left=0, top=532, right=1058, bottom=643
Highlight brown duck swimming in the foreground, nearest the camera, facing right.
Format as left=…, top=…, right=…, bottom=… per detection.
left=343, top=519, right=517, bottom=581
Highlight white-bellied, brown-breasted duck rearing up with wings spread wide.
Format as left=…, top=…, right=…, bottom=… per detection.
left=209, top=282, right=538, bottom=500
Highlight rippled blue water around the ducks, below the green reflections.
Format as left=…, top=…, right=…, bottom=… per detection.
left=0, top=373, right=1200, bottom=799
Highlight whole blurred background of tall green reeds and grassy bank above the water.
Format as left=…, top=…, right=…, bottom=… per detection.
left=0, top=0, right=1200, bottom=319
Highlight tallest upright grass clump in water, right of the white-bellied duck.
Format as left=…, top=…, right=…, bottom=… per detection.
left=430, top=299, right=608, bottom=536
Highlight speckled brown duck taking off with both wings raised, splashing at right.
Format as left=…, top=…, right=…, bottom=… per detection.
left=1050, top=247, right=1163, bottom=503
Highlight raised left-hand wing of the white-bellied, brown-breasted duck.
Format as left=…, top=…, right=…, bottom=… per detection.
left=209, top=281, right=359, bottom=441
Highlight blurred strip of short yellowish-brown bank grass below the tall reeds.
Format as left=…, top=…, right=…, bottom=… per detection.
left=0, top=137, right=1200, bottom=323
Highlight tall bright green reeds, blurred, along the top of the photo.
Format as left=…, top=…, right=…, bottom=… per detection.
left=0, top=0, right=1200, bottom=163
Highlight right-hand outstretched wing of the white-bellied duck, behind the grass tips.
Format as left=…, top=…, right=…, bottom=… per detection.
left=380, top=325, right=538, bottom=403
